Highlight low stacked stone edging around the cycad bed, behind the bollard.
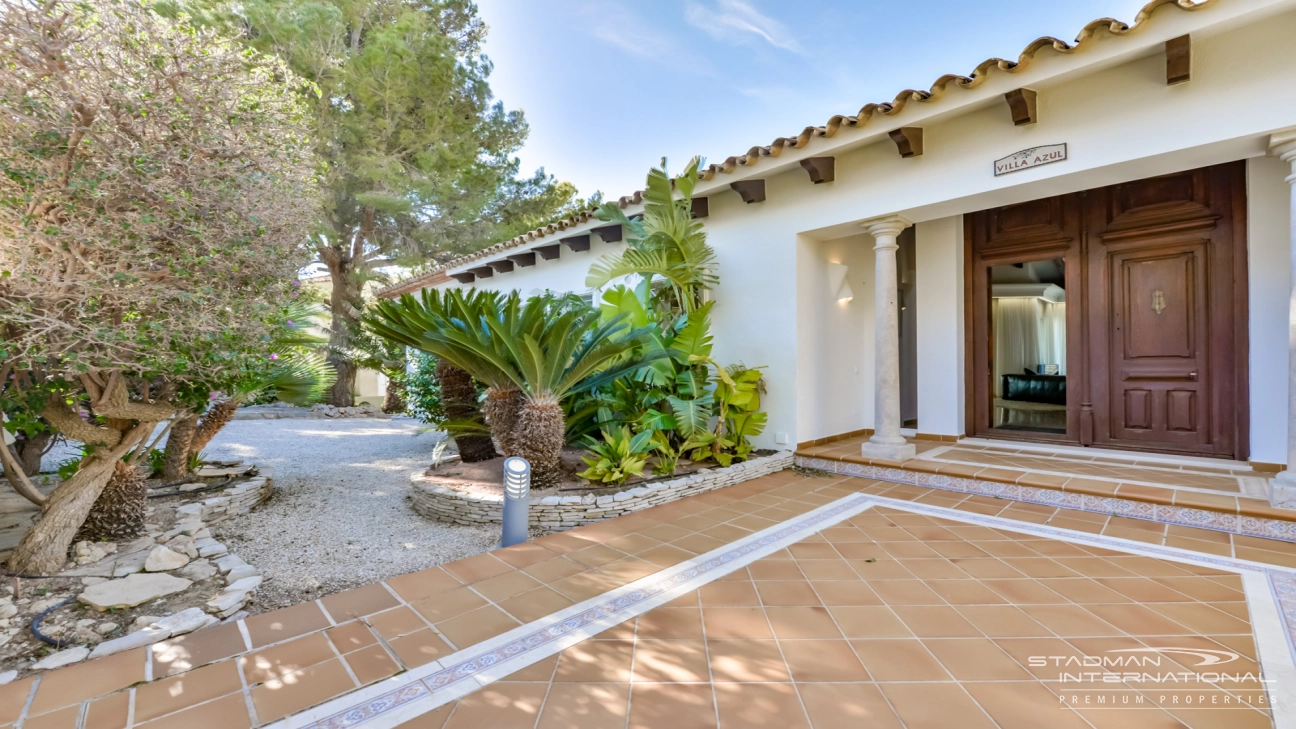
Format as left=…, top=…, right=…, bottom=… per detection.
left=410, top=451, right=793, bottom=529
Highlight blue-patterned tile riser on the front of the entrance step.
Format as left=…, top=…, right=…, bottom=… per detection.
left=796, top=455, right=1296, bottom=542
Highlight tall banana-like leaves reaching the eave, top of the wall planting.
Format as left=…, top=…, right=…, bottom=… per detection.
left=584, top=157, right=719, bottom=317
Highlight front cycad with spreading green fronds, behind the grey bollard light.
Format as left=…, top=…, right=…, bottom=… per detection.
left=369, top=289, right=665, bottom=488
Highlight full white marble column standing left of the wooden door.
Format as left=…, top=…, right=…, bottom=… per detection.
left=861, top=215, right=914, bottom=460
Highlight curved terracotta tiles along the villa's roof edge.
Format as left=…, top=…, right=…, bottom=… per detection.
left=377, top=0, right=1202, bottom=298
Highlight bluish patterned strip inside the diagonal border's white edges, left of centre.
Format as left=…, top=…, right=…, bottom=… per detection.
left=286, top=494, right=868, bottom=729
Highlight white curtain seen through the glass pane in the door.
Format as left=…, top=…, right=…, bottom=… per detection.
left=990, top=297, right=1067, bottom=397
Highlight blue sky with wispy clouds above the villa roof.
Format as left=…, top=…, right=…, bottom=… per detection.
left=477, top=0, right=1146, bottom=196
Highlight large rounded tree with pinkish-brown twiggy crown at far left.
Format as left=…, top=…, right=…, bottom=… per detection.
left=0, top=0, right=319, bottom=572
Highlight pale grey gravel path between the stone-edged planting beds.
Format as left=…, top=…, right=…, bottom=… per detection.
left=205, top=418, right=499, bottom=610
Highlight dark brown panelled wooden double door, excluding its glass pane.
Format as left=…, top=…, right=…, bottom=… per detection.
left=966, top=162, right=1249, bottom=459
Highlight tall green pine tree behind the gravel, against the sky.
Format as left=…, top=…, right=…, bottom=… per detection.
left=178, top=0, right=584, bottom=406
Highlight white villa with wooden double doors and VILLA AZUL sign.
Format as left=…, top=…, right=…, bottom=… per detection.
left=380, top=0, right=1296, bottom=503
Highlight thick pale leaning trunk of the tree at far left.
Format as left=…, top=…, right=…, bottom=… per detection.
left=9, top=422, right=157, bottom=575
